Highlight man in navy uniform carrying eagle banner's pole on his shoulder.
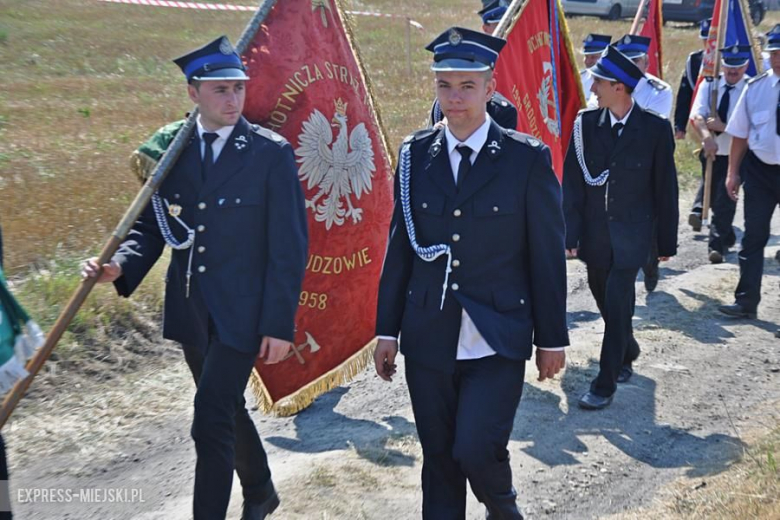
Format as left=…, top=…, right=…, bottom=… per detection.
left=84, top=36, right=307, bottom=520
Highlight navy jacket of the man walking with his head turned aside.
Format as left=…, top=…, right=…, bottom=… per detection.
left=563, top=103, right=678, bottom=269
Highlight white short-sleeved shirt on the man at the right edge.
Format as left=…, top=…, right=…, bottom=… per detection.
left=726, top=69, right=780, bottom=165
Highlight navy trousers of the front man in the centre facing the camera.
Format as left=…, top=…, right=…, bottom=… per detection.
left=406, top=355, right=525, bottom=520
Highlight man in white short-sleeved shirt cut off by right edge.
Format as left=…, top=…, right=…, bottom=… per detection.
left=718, top=24, right=780, bottom=318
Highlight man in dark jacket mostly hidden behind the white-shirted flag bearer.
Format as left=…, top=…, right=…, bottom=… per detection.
left=674, top=18, right=712, bottom=231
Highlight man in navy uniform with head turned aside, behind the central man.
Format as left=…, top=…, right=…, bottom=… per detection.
left=563, top=46, right=678, bottom=410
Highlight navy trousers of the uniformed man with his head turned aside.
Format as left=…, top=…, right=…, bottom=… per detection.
left=588, top=266, right=639, bottom=397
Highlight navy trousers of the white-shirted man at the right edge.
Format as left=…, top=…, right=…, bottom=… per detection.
left=735, top=152, right=780, bottom=311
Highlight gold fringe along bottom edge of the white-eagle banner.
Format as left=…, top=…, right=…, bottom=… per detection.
left=250, top=339, right=376, bottom=417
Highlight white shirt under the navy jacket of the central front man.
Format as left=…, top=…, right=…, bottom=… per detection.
left=378, top=112, right=565, bottom=360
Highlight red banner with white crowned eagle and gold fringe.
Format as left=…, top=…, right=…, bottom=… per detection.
left=243, top=0, right=393, bottom=414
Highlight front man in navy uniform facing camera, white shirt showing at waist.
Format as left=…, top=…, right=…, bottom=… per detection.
left=374, top=27, right=569, bottom=520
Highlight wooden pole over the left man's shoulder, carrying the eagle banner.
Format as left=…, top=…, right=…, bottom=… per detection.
left=0, top=0, right=276, bottom=429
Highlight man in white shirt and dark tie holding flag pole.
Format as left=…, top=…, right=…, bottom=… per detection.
left=691, top=45, right=750, bottom=264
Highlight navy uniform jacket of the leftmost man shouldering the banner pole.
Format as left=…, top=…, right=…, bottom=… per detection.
left=115, top=117, right=307, bottom=353
